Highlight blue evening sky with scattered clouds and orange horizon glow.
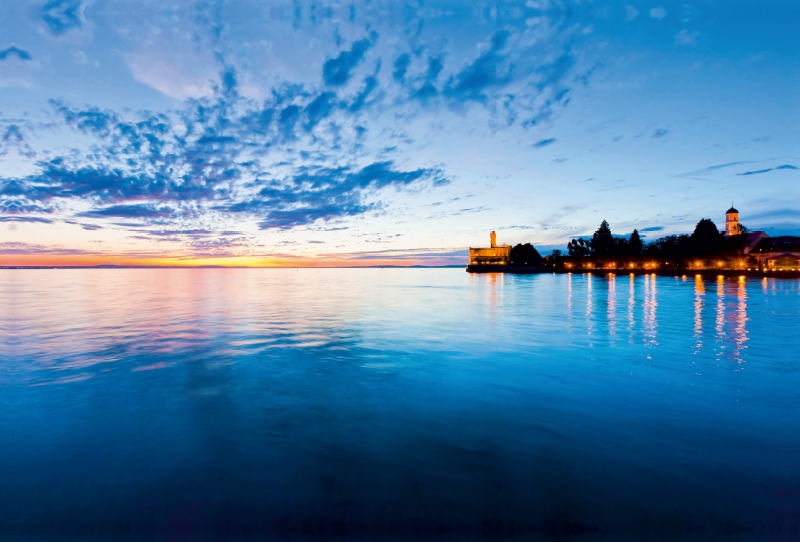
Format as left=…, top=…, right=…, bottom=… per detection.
left=0, top=0, right=800, bottom=266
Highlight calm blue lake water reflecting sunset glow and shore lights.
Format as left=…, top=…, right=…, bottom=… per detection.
left=0, top=269, right=800, bottom=540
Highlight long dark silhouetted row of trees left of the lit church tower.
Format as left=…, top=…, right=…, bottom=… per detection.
left=564, top=218, right=748, bottom=261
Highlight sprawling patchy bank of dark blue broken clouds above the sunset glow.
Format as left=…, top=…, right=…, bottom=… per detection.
left=0, top=0, right=585, bottom=239
